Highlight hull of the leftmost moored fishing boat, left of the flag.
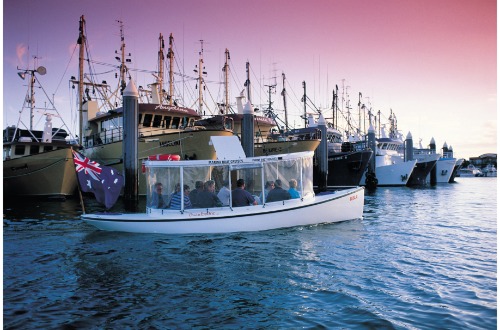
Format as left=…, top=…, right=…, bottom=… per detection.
left=3, top=148, right=77, bottom=197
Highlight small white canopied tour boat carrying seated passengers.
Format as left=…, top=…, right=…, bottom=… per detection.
left=82, top=137, right=364, bottom=234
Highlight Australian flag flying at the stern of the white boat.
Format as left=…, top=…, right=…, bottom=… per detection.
left=73, top=150, right=125, bottom=209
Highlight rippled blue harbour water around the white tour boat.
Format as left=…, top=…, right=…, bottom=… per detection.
left=3, top=178, right=497, bottom=329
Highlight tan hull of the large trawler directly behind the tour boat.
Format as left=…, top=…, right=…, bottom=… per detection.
left=83, top=130, right=233, bottom=195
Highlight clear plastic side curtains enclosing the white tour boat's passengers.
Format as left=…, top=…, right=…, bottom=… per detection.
left=146, top=153, right=314, bottom=211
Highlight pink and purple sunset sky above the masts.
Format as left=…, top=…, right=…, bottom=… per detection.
left=3, top=0, right=497, bottom=158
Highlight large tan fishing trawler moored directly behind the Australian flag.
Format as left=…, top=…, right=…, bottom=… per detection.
left=71, top=16, right=233, bottom=195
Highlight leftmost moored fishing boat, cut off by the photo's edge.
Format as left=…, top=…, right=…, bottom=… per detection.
left=3, top=66, right=77, bottom=197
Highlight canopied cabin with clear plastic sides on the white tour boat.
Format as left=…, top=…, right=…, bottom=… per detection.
left=144, top=137, right=314, bottom=214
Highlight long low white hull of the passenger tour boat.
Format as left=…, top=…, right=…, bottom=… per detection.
left=82, top=187, right=364, bottom=234
